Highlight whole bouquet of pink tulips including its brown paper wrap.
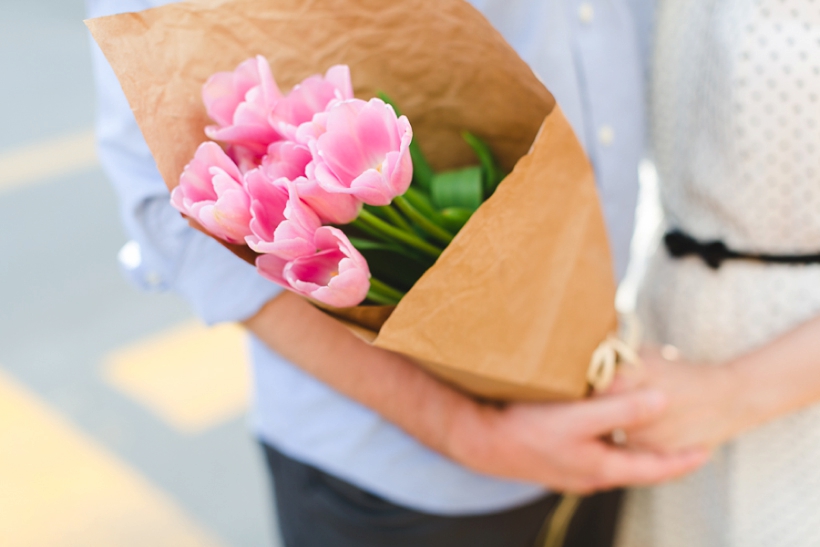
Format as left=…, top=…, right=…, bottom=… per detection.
left=88, top=0, right=616, bottom=400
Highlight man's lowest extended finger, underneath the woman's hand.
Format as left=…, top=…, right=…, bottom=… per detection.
left=596, top=448, right=709, bottom=488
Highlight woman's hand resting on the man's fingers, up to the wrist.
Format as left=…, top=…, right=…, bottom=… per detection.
left=610, top=348, right=750, bottom=453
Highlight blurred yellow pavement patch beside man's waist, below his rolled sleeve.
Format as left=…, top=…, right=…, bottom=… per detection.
left=103, top=323, right=249, bottom=433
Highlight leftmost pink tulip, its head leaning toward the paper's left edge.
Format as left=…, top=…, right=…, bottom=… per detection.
left=171, top=142, right=251, bottom=243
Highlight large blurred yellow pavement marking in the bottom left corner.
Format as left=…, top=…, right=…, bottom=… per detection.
left=0, top=371, right=224, bottom=547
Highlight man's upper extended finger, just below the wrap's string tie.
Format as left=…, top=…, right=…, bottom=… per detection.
left=573, top=389, right=666, bottom=436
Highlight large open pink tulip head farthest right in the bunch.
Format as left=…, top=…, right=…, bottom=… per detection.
left=308, top=99, right=413, bottom=205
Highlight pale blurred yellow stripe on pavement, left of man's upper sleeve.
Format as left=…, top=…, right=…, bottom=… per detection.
left=0, top=129, right=97, bottom=194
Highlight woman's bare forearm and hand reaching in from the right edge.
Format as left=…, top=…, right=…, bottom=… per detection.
left=613, top=317, right=820, bottom=451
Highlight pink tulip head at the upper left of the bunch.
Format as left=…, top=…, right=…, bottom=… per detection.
left=202, top=55, right=282, bottom=156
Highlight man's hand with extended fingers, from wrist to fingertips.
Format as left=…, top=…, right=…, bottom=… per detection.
left=449, top=390, right=708, bottom=494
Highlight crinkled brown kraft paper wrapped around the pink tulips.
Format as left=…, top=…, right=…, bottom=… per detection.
left=87, top=0, right=615, bottom=399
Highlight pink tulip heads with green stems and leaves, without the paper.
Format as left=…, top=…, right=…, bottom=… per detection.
left=171, top=56, right=501, bottom=308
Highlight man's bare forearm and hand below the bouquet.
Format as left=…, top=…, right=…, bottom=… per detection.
left=244, top=293, right=707, bottom=493
